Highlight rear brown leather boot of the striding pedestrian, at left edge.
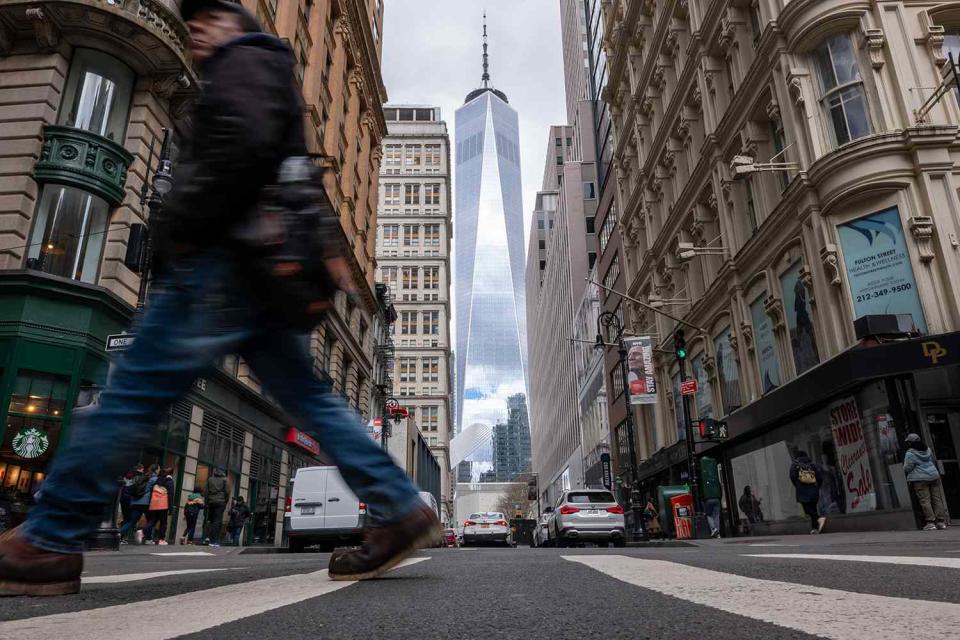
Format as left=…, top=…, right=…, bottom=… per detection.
left=0, top=529, right=83, bottom=596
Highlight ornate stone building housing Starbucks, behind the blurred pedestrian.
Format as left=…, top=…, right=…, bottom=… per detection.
left=0, top=0, right=386, bottom=542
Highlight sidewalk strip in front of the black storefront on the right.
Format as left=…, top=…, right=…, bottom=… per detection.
left=692, top=526, right=960, bottom=552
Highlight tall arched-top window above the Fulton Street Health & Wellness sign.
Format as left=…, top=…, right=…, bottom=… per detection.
left=814, top=33, right=872, bottom=145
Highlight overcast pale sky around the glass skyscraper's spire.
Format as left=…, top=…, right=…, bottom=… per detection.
left=383, top=0, right=566, bottom=240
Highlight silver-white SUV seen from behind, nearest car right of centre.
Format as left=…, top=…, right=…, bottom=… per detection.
left=548, top=489, right=626, bottom=547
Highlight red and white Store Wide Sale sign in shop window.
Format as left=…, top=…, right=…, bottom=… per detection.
left=829, top=397, right=877, bottom=513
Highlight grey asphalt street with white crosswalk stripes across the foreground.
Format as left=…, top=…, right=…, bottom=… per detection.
left=0, top=527, right=960, bottom=640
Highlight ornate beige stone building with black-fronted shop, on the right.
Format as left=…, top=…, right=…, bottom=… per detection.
left=604, top=0, right=960, bottom=531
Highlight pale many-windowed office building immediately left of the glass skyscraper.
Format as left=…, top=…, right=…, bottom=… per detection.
left=377, top=105, right=453, bottom=522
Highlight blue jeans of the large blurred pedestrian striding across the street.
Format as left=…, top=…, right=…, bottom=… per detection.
left=21, top=250, right=422, bottom=553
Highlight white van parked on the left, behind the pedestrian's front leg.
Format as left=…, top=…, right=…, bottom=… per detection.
left=283, top=467, right=367, bottom=552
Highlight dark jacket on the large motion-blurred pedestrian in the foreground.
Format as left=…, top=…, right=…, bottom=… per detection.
left=155, top=33, right=306, bottom=270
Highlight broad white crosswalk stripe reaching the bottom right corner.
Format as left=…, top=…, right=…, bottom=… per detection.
left=562, top=556, right=960, bottom=640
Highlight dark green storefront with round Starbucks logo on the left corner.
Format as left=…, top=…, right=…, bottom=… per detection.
left=0, top=270, right=133, bottom=530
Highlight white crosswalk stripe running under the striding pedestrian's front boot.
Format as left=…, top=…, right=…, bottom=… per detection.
left=0, top=557, right=430, bottom=640
